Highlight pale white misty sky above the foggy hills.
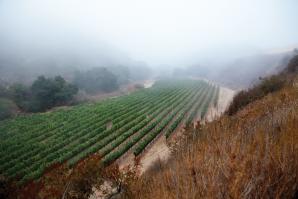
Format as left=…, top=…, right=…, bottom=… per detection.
left=0, top=0, right=298, bottom=66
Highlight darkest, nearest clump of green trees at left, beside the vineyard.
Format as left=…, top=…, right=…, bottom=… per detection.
left=0, top=76, right=78, bottom=116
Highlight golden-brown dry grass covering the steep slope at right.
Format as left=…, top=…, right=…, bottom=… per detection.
left=126, top=88, right=298, bottom=199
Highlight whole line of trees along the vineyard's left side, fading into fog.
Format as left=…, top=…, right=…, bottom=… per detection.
left=0, top=66, right=148, bottom=120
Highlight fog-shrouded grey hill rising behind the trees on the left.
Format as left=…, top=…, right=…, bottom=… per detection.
left=0, top=37, right=150, bottom=84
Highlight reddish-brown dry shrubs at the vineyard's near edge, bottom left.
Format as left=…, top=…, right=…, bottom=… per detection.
left=16, top=154, right=120, bottom=199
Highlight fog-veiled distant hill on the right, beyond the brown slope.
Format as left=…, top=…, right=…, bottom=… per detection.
left=173, top=49, right=298, bottom=89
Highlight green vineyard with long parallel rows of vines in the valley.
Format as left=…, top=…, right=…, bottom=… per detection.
left=0, top=80, right=219, bottom=182
